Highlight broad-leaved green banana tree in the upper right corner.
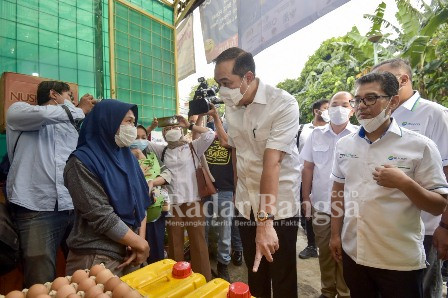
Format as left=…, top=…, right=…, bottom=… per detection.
left=365, top=0, right=448, bottom=102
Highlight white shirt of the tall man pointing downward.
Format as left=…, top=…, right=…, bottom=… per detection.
left=226, top=80, right=299, bottom=220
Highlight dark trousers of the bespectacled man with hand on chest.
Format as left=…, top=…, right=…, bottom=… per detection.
left=342, top=251, right=423, bottom=298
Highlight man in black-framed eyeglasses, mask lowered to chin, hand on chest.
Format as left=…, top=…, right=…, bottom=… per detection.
left=330, top=72, right=448, bottom=298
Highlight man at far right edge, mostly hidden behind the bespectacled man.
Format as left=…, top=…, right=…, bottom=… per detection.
left=373, top=58, right=448, bottom=298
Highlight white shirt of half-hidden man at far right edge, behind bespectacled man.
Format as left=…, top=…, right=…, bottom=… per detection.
left=392, top=91, right=448, bottom=235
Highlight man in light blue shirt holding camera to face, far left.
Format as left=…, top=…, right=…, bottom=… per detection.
left=6, top=81, right=96, bottom=288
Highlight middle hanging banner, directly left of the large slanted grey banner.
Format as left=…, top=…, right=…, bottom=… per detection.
left=199, top=0, right=240, bottom=63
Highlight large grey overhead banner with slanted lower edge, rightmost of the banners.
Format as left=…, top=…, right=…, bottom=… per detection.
left=238, top=0, right=350, bottom=55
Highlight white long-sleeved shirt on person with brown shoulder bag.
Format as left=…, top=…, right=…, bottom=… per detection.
left=148, top=130, right=215, bottom=204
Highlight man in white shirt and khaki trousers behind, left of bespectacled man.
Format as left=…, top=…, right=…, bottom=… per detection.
left=300, top=92, right=357, bottom=297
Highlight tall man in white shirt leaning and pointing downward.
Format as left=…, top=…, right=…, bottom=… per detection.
left=215, top=48, right=299, bottom=297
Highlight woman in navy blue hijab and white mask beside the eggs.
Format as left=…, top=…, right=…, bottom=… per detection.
left=64, top=100, right=150, bottom=276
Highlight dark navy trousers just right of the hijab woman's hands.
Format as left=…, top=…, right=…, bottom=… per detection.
left=146, top=212, right=166, bottom=264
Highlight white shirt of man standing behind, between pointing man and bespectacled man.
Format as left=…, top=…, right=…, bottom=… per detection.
left=300, top=123, right=358, bottom=214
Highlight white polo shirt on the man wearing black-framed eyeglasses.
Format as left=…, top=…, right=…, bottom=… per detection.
left=331, top=119, right=448, bottom=271
